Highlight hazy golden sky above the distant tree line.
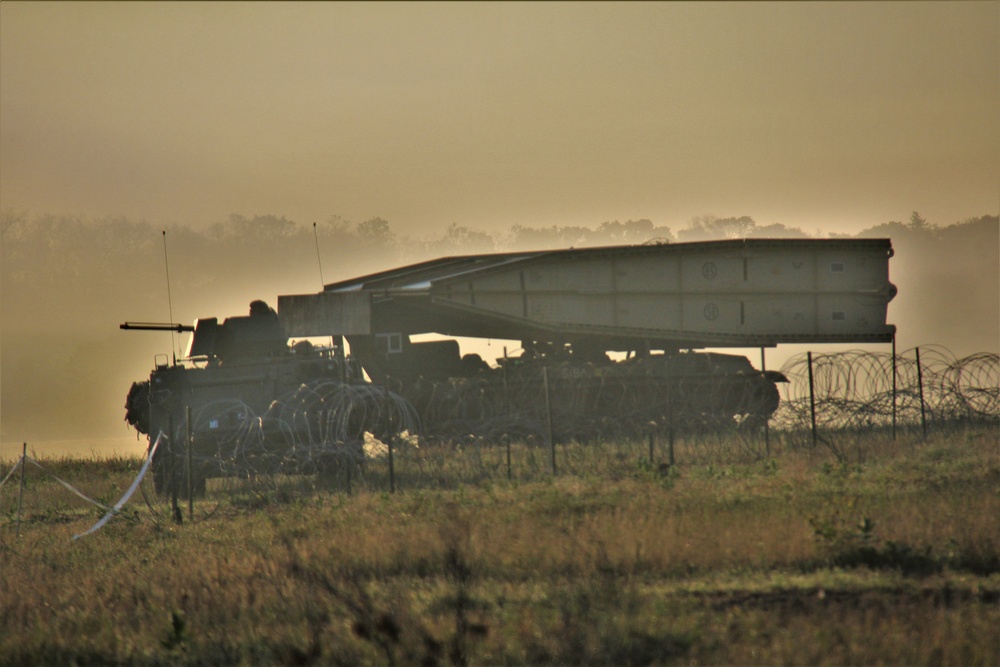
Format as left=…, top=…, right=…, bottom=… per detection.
left=0, top=2, right=1000, bottom=233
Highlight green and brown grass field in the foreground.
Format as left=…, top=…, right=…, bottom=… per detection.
left=0, top=426, right=1000, bottom=665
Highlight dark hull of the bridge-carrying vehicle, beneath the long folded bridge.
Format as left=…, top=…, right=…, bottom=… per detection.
left=404, top=355, right=778, bottom=442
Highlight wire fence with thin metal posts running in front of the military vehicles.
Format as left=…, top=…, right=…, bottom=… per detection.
left=145, top=347, right=1000, bottom=497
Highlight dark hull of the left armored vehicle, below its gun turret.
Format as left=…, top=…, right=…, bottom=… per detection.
left=125, top=349, right=369, bottom=494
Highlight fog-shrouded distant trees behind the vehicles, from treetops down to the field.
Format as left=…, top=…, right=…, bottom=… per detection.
left=0, top=206, right=1000, bottom=438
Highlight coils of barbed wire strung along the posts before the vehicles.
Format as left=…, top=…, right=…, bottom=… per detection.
left=160, top=347, right=1000, bottom=476
